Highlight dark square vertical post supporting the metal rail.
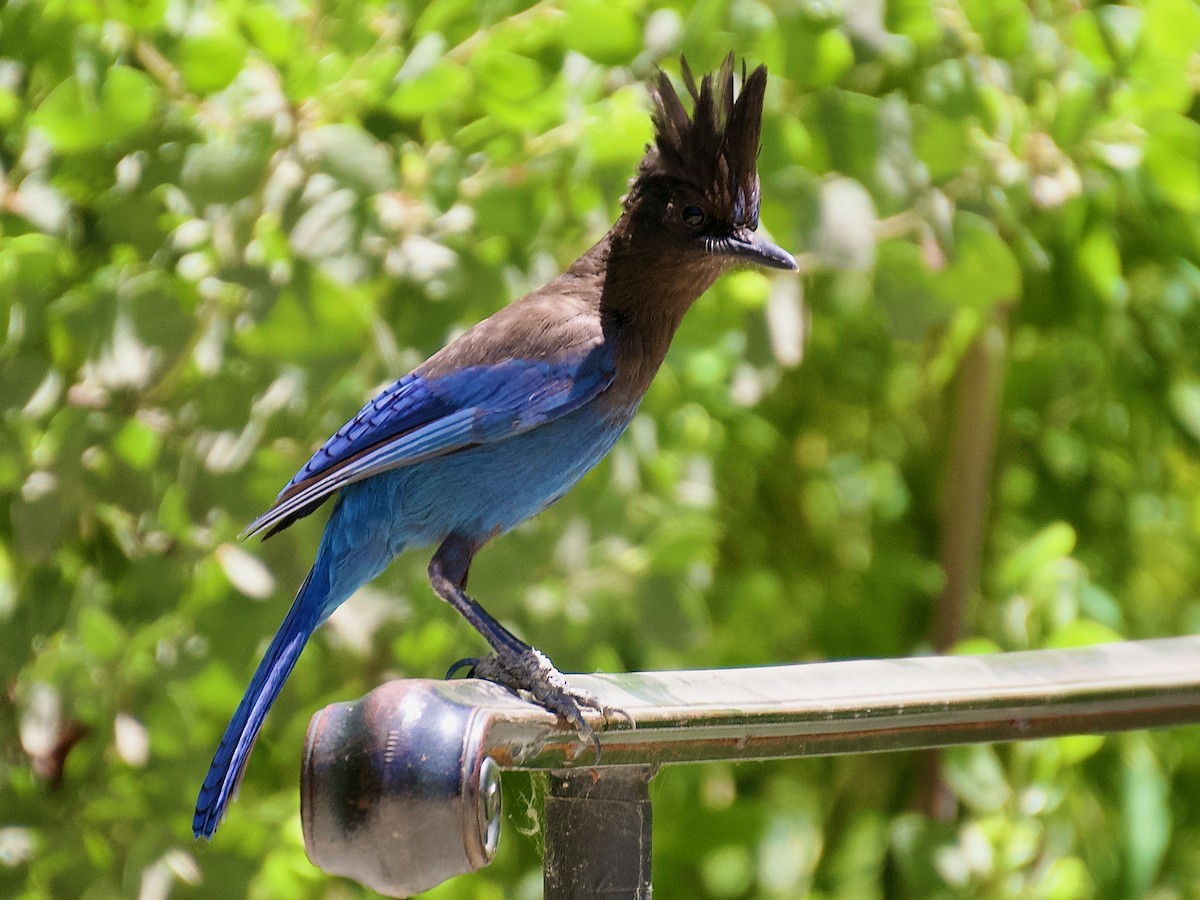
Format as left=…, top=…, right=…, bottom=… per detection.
left=542, top=766, right=655, bottom=900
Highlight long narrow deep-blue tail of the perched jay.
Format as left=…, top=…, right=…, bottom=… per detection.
left=192, top=571, right=329, bottom=838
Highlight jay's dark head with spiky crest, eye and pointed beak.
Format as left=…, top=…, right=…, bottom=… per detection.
left=625, top=53, right=796, bottom=270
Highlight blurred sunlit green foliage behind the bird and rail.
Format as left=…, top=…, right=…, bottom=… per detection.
left=0, top=0, right=1200, bottom=900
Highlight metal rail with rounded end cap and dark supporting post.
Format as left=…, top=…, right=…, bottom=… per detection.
left=301, top=637, right=1200, bottom=900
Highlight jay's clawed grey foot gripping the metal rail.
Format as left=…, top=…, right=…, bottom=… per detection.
left=446, top=647, right=634, bottom=762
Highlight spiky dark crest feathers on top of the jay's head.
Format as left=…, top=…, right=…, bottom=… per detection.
left=631, top=53, right=767, bottom=228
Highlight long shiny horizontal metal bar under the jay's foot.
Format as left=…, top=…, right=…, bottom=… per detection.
left=470, top=636, right=1200, bottom=769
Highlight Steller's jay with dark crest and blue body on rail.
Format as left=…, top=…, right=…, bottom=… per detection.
left=192, top=54, right=796, bottom=838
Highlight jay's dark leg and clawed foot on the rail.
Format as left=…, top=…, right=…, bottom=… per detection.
left=430, top=535, right=629, bottom=758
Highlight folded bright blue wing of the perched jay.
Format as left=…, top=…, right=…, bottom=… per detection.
left=244, top=344, right=616, bottom=536
